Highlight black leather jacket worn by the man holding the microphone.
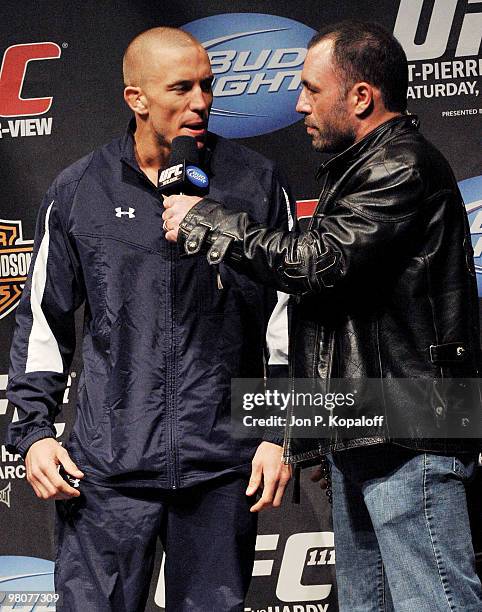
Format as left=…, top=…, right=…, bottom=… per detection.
left=179, top=116, right=480, bottom=462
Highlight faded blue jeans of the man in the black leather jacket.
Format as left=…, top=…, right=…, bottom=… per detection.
left=329, top=444, right=482, bottom=612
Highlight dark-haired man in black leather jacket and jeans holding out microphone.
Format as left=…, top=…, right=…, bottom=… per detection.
left=164, top=22, right=482, bottom=612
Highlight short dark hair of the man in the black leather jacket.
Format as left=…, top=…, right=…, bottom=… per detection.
left=308, top=20, right=408, bottom=112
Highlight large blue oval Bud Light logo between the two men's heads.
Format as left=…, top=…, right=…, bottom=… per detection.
left=183, top=13, right=315, bottom=138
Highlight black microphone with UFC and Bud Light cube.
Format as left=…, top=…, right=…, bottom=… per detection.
left=157, top=136, right=209, bottom=195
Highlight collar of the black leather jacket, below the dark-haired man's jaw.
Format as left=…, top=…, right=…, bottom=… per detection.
left=316, top=115, right=420, bottom=179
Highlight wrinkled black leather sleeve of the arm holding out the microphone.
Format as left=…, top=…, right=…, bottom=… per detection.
left=178, top=160, right=423, bottom=294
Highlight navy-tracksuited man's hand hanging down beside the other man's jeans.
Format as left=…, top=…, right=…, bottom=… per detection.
left=246, top=442, right=291, bottom=512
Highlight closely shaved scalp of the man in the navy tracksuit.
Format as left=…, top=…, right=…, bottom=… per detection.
left=122, top=27, right=202, bottom=87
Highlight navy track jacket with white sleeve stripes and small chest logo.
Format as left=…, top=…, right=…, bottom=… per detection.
left=7, top=124, right=289, bottom=488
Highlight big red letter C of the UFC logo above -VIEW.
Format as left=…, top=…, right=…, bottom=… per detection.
left=0, top=42, right=61, bottom=117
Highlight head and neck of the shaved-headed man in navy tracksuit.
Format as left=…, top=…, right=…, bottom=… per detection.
left=123, top=27, right=214, bottom=164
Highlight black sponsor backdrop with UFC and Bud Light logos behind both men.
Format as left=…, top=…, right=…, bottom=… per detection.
left=0, top=0, right=482, bottom=612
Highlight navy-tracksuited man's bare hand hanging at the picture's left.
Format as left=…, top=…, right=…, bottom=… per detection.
left=25, top=438, right=84, bottom=499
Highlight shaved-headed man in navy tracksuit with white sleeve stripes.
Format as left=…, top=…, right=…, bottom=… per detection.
left=8, top=28, right=290, bottom=612
